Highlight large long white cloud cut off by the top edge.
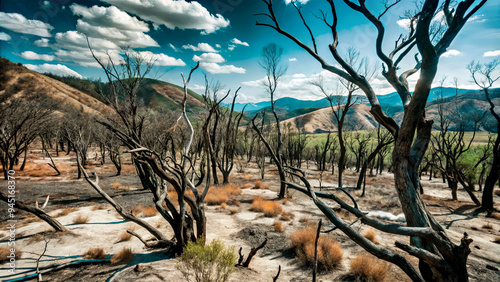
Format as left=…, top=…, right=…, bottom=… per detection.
left=103, top=0, right=229, bottom=34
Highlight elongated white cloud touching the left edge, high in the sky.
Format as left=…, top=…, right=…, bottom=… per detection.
left=0, top=12, right=54, bottom=37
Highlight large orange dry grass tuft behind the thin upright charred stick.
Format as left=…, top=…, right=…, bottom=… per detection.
left=290, top=227, right=344, bottom=271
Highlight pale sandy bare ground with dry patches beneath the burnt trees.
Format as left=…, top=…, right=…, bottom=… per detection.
left=0, top=161, right=500, bottom=282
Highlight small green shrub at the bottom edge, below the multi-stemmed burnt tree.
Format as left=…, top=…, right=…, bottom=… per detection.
left=177, top=240, right=236, bottom=282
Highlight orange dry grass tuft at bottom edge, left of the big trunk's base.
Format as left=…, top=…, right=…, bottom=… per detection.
left=351, top=254, right=390, bottom=282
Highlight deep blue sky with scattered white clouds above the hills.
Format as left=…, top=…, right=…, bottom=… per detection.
left=0, top=0, right=500, bottom=102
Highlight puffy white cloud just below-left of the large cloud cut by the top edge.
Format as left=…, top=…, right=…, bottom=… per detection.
left=70, top=4, right=159, bottom=48
